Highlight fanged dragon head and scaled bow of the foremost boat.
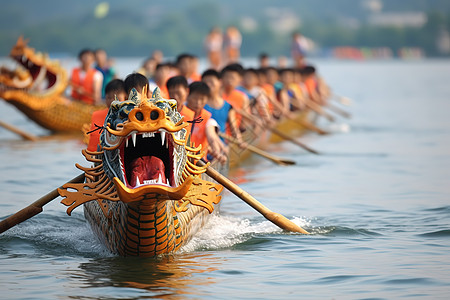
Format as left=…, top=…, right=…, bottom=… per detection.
left=58, top=89, right=223, bottom=256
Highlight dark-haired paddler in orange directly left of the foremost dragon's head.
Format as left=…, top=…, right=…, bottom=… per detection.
left=86, top=79, right=127, bottom=151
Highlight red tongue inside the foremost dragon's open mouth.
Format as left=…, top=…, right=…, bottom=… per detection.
left=130, top=156, right=166, bottom=187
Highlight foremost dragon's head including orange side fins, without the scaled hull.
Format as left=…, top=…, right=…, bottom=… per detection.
left=60, top=87, right=222, bottom=214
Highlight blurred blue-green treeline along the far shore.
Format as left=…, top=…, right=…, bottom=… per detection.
left=0, top=0, right=450, bottom=56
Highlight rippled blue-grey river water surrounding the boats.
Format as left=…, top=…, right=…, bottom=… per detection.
left=0, top=59, right=450, bottom=299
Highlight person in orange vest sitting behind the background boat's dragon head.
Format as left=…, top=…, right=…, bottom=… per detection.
left=69, top=49, right=103, bottom=105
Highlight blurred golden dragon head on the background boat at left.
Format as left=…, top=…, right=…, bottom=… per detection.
left=0, top=37, right=68, bottom=109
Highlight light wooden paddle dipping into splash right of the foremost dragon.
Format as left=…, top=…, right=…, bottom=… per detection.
left=197, top=160, right=309, bottom=234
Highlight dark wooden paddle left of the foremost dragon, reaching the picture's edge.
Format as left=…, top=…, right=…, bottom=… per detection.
left=0, top=173, right=84, bottom=233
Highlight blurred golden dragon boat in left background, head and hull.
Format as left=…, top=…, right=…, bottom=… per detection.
left=0, top=37, right=104, bottom=132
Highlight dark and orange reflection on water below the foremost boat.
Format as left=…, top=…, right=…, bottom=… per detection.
left=77, top=252, right=221, bottom=299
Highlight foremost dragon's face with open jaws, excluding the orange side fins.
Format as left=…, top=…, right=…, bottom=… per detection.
left=100, top=88, right=206, bottom=203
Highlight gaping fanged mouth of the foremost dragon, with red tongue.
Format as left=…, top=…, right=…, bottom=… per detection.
left=119, top=131, right=177, bottom=189
